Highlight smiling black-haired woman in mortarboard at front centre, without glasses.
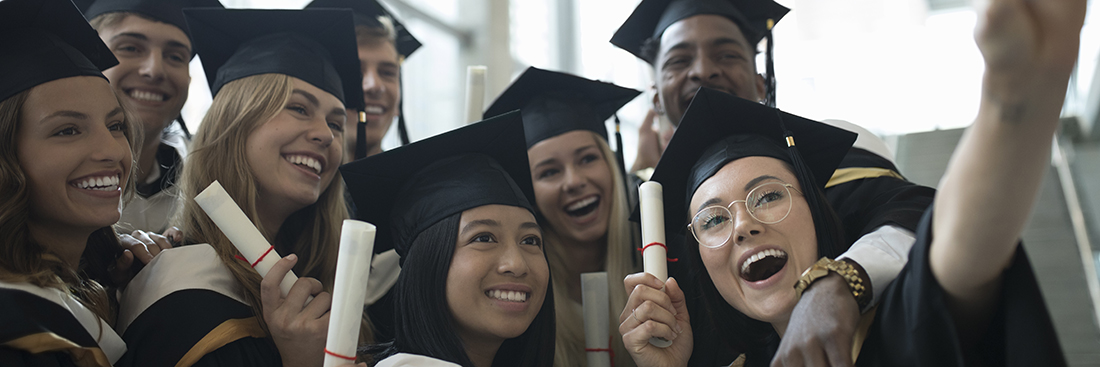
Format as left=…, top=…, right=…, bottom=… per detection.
left=341, top=113, right=554, bottom=367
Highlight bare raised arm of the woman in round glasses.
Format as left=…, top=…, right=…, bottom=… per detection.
left=931, top=0, right=1086, bottom=341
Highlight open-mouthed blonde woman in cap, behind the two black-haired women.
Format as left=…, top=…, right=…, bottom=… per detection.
left=485, top=67, right=640, bottom=366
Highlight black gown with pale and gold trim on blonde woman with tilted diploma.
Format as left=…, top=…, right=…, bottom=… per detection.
left=116, top=244, right=282, bottom=367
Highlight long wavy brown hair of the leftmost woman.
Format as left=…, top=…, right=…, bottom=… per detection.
left=0, top=80, right=141, bottom=324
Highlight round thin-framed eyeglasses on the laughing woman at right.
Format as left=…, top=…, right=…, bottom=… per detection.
left=688, top=182, right=802, bottom=248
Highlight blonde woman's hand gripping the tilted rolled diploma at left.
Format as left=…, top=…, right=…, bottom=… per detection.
left=260, top=254, right=332, bottom=367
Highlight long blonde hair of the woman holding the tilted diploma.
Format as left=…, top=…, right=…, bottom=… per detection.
left=173, top=74, right=372, bottom=342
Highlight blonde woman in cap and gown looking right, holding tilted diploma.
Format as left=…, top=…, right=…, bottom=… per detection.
left=119, top=10, right=370, bottom=366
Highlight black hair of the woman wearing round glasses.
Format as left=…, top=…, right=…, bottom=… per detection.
left=684, top=164, right=846, bottom=366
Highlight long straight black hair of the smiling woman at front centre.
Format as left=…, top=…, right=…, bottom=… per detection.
left=361, top=212, right=554, bottom=367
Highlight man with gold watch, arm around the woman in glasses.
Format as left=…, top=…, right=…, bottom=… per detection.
left=612, top=0, right=934, bottom=365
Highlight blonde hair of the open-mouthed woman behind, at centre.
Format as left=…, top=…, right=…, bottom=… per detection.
left=542, top=133, right=639, bottom=367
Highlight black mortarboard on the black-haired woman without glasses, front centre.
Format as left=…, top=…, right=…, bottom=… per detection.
left=340, top=112, right=535, bottom=256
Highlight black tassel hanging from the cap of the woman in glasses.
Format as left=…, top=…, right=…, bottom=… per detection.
left=776, top=110, right=846, bottom=258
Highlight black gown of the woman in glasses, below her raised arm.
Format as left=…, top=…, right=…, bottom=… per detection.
left=856, top=210, right=1066, bottom=367
